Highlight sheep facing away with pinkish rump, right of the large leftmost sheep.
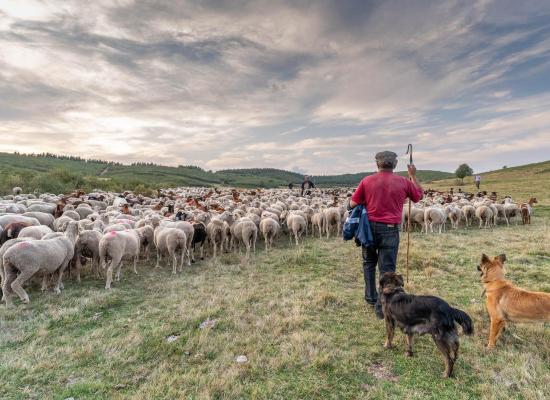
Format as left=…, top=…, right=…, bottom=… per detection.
left=99, top=229, right=140, bottom=290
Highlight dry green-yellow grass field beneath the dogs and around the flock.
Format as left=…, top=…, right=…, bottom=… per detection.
left=0, top=167, right=550, bottom=399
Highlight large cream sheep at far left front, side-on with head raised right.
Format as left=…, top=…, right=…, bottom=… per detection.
left=3, top=222, right=78, bottom=306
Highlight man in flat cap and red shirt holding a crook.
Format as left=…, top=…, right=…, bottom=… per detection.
left=349, top=151, right=423, bottom=319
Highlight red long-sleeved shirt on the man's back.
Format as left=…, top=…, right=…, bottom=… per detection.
left=351, top=171, right=423, bottom=224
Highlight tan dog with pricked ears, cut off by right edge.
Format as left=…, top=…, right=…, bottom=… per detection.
left=477, top=254, right=550, bottom=349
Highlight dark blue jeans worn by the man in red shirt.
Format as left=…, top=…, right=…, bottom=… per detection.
left=362, top=221, right=400, bottom=305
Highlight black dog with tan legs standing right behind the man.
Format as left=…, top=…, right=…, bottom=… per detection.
left=380, top=272, right=474, bottom=378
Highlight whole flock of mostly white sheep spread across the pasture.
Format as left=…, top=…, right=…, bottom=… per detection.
left=0, top=187, right=536, bottom=305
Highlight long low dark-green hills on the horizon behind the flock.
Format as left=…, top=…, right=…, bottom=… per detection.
left=0, top=153, right=452, bottom=193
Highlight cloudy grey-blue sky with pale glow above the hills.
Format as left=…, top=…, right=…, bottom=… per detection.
left=0, top=0, right=550, bottom=175
